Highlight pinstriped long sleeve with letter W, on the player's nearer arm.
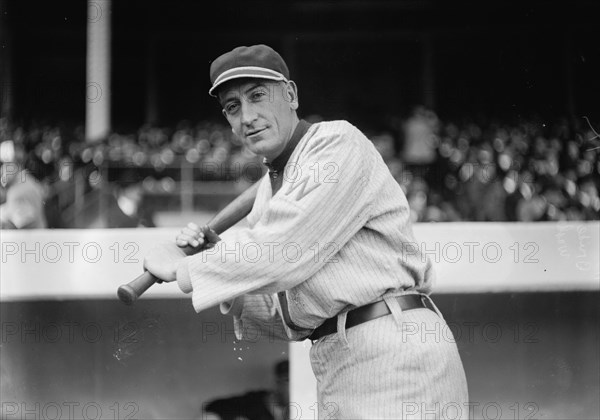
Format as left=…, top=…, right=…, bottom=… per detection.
left=178, top=122, right=375, bottom=312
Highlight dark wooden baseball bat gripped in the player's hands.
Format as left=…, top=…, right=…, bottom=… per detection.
left=117, top=182, right=259, bottom=305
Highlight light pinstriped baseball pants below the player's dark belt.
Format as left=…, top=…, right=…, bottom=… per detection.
left=310, top=299, right=469, bottom=420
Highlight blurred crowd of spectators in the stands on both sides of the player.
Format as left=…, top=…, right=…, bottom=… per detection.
left=0, top=108, right=600, bottom=227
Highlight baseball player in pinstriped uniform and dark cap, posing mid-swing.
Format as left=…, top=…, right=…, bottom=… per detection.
left=144, top=45, right=468, bottom=419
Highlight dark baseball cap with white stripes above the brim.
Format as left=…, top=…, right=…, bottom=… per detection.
left=208, top=44, right=290, bottom=97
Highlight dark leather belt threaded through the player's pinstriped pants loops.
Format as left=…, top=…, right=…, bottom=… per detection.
left=308, top=294, right=437, bottom=341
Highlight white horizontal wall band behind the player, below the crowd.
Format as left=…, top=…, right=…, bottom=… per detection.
left=0, top=222, right=600, bottom=300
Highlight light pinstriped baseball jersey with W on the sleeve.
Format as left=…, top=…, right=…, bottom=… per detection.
left=177, top=121, right=434, bottom=339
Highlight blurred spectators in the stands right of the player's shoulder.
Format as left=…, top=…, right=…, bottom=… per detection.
left=371, top=108, right=600, bottom=222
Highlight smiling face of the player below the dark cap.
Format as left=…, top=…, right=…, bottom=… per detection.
left=219, top=79, right=298, bottom=160
